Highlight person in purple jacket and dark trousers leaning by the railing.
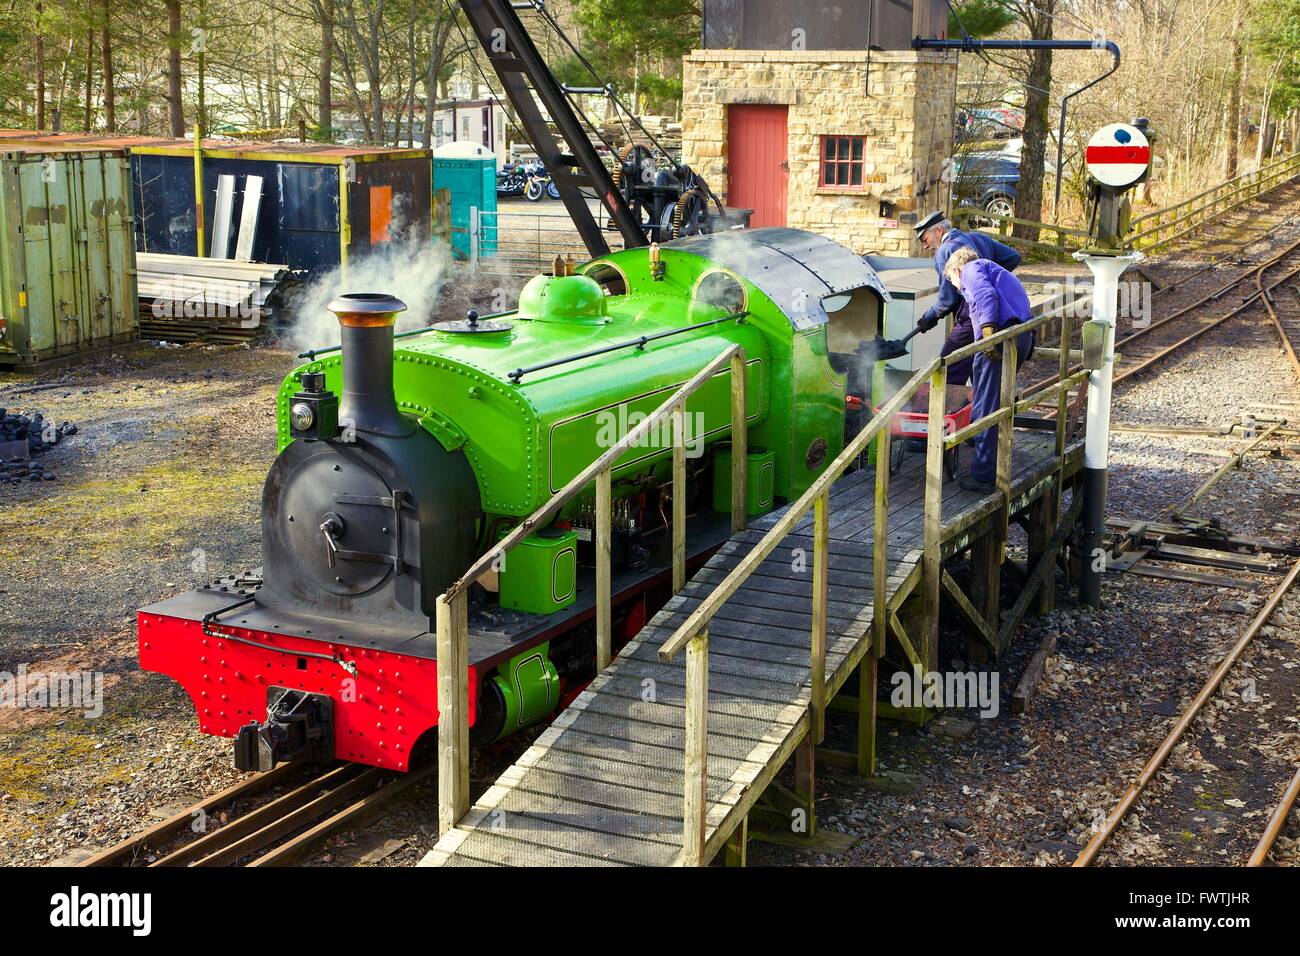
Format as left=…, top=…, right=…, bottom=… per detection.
left=944, top=247, right=1034, bottom=492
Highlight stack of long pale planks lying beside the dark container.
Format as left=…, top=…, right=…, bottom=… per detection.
left=135, top=252, right=290, bottom=342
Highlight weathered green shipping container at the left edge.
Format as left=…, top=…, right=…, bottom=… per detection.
left=0, top=144, right=139, bottom=365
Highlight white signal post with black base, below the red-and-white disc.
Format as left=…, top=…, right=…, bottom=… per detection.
left=1074, top=252, right=1143, bottom=607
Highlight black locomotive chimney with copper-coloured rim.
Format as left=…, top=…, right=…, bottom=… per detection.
left=326, top=293, right=415, bottom=438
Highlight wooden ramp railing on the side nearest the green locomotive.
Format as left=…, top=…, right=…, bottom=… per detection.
left=437, top=345, right=748, bottom=836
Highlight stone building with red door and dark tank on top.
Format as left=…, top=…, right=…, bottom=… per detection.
left=683, top=0, right=957, bottom=255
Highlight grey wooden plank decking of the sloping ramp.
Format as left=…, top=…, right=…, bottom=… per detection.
left=421, top=431, right=1079, bottom=866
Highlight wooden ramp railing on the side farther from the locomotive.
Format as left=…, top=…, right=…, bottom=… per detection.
left=659, top=306, right=1088, bottom=865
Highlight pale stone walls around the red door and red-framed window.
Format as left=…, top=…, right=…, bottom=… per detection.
left=683, top=49, right=957, bottom=255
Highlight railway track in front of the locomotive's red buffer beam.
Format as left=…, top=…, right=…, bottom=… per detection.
left=81, top=763, right=436, bottom=866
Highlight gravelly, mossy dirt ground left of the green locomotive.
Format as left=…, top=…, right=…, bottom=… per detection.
left=0, top=345, right=296, bottom=862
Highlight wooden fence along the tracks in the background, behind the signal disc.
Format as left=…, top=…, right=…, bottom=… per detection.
left=950, top=147, right=1300, bottom=258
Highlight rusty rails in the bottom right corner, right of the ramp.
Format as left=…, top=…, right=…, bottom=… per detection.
left=1074, top=561, right=1300, bottom=866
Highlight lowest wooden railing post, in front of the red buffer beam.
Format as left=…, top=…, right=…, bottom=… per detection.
left=436, top=593, right=469, bottom=836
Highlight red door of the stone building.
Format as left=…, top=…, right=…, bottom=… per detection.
left=727, top=104, right=790, bottom=228
